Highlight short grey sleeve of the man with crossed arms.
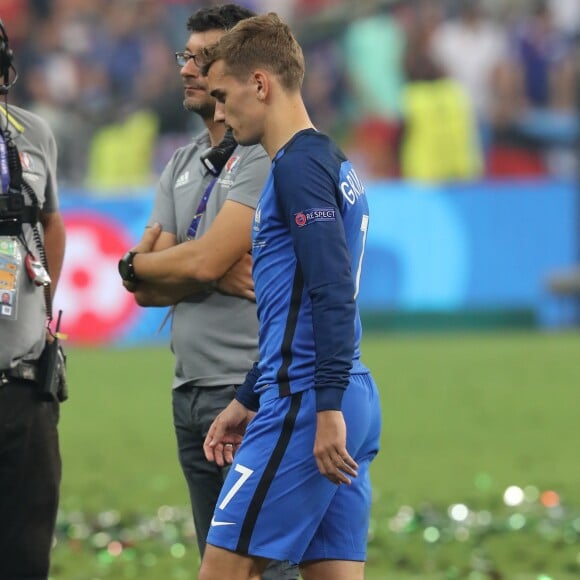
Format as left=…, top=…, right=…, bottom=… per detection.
left=228, top=145, right=270, bottom=209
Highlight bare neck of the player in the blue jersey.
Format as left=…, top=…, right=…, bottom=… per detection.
left=262, top=94, right=315, bottom=159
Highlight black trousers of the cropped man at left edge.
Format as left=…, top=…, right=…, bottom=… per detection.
left=0, top=379, right=62, bottom=580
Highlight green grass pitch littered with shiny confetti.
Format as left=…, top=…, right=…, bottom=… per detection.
left=51, top=332, right=580, bottom=580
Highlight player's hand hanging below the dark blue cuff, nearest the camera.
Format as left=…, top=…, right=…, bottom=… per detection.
left=314, top=411, right=358, bottom=484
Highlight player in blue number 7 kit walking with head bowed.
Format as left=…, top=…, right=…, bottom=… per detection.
left=199, top=14, right=381, bottom=580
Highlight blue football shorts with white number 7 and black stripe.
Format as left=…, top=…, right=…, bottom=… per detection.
left=207, top=373, right=381, bottom=563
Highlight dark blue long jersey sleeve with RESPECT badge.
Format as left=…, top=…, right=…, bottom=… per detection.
left=274, top=151, right=356, bottom=411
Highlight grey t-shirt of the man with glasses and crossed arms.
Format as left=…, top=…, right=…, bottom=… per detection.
left=150, top=131, right=270, bottom=388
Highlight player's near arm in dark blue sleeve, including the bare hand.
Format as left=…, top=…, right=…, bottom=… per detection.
left=275, top=153, right=358, bottom=484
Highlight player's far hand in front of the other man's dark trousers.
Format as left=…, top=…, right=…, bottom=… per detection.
left=203, top=399, right=255, bottom=467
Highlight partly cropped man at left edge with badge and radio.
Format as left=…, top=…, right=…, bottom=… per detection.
left=0, top=23, right=65, bottom=580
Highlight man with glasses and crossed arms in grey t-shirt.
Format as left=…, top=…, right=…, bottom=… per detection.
left=120, top=4, right=298, bottom=579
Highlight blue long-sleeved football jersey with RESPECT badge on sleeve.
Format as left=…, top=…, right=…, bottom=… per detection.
left=248, top=129, right=369, bottom=410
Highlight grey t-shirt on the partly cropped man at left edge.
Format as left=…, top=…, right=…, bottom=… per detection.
left=0, top=105, right=58, bottom=369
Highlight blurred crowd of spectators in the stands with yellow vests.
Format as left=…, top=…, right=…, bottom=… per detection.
left=0, top=0, right=580, bottom=192
